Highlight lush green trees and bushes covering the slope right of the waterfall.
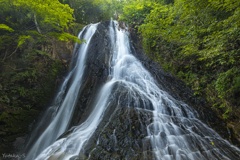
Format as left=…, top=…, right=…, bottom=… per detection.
left=120, top=0, right=240, bottom=120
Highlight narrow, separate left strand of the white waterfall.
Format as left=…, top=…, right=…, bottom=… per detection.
left=25, top=24, right=97, bottom=160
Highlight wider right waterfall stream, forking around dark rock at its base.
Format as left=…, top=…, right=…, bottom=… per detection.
left=34, top=21, right=240, bottom=160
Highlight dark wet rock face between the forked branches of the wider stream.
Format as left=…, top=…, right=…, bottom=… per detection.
left=87, top=106, right=154, bottom=160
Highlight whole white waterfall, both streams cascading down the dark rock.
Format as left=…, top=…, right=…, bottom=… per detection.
left=24, top=21, right=240, bottom=160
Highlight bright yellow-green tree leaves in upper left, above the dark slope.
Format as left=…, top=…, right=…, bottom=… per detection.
left=0, top=0, right=81, bottom=61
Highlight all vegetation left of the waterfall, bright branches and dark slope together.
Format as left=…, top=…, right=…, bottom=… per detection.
left=0, top=0, right=120, bottom=144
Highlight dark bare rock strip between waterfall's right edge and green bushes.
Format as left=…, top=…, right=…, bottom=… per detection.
left=130, top=31, right=240, bottom=147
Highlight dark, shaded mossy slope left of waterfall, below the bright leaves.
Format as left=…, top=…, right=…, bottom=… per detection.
left=0, top=50, right=63, bottom=153
